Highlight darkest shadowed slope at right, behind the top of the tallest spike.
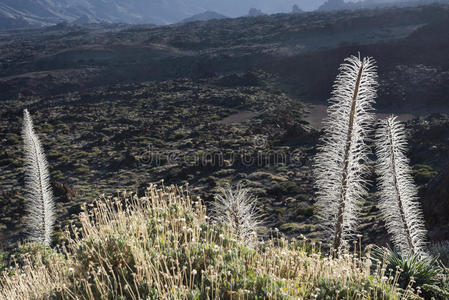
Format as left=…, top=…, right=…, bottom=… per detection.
left=267, top=16, right=449, bottom=113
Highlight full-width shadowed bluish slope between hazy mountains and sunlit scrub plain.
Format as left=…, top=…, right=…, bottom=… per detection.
left=0, top=6, right=449, bottom=112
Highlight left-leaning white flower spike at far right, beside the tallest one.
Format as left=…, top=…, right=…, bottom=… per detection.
left=376, top=116, right=426, bottom=256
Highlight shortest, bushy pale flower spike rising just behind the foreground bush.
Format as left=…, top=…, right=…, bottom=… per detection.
left=212, top=185, right=261, bottom=247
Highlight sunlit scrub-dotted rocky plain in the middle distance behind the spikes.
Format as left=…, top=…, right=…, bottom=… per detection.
left=0, top=73, right=449, bottom=250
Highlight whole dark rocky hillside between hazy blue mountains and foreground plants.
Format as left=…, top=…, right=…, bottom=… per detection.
left=0, top=6, right=449, bottom=248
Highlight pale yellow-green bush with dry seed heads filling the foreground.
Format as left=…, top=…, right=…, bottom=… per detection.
left=0, top=186, right=415, bottom=299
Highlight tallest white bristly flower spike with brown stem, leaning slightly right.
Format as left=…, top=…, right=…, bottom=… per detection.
left=314, top=56, right=377, bottom=249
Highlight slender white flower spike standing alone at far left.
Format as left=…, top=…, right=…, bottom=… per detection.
left=22, top=109, right=55, bottom=246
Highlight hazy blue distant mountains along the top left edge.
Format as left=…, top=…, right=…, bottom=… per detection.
left=0, top=0, right=310, bottom=29
